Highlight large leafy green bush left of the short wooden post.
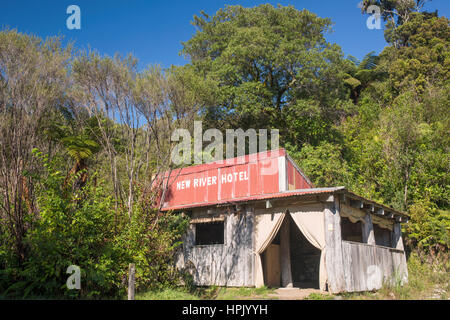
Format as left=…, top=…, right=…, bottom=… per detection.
left=13, top=153, right=124, bottom=298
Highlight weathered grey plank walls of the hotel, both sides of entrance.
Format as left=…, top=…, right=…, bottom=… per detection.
left=177, top=196, right=408, bottom=294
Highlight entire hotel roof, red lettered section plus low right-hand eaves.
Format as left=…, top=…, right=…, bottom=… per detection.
left=160, top=149, right=407, bottom=219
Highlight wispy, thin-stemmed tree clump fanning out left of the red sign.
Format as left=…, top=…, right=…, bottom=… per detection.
left=72, top=52, right=203, bottom=219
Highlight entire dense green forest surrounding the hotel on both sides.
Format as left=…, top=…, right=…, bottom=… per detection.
left=0, top=1, right=450, bottom=298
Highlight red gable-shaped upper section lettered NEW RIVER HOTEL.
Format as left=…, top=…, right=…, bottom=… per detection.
left=160, top=149, right=313, bottom=211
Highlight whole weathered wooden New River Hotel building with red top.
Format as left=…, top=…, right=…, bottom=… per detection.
left=161, top=149, right=408, bottom=293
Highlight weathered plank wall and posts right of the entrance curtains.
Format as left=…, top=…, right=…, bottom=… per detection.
left=325, top=198, right=408, bottom=293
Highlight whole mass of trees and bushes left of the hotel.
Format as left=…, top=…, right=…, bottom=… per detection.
left=0, top=31, right=193, bottom=297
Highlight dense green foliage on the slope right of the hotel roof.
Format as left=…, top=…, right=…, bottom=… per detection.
left=339, top=13, right=450, bottom=252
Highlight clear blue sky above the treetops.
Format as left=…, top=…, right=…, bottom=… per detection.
left=0, top=0, right=450, bottom=68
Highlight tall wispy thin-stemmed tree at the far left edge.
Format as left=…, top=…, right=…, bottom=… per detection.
left=0, top=31, right=70, bottom=264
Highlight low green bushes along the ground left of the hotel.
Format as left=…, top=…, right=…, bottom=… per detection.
left=0, top=151, right=187, bottom=299
